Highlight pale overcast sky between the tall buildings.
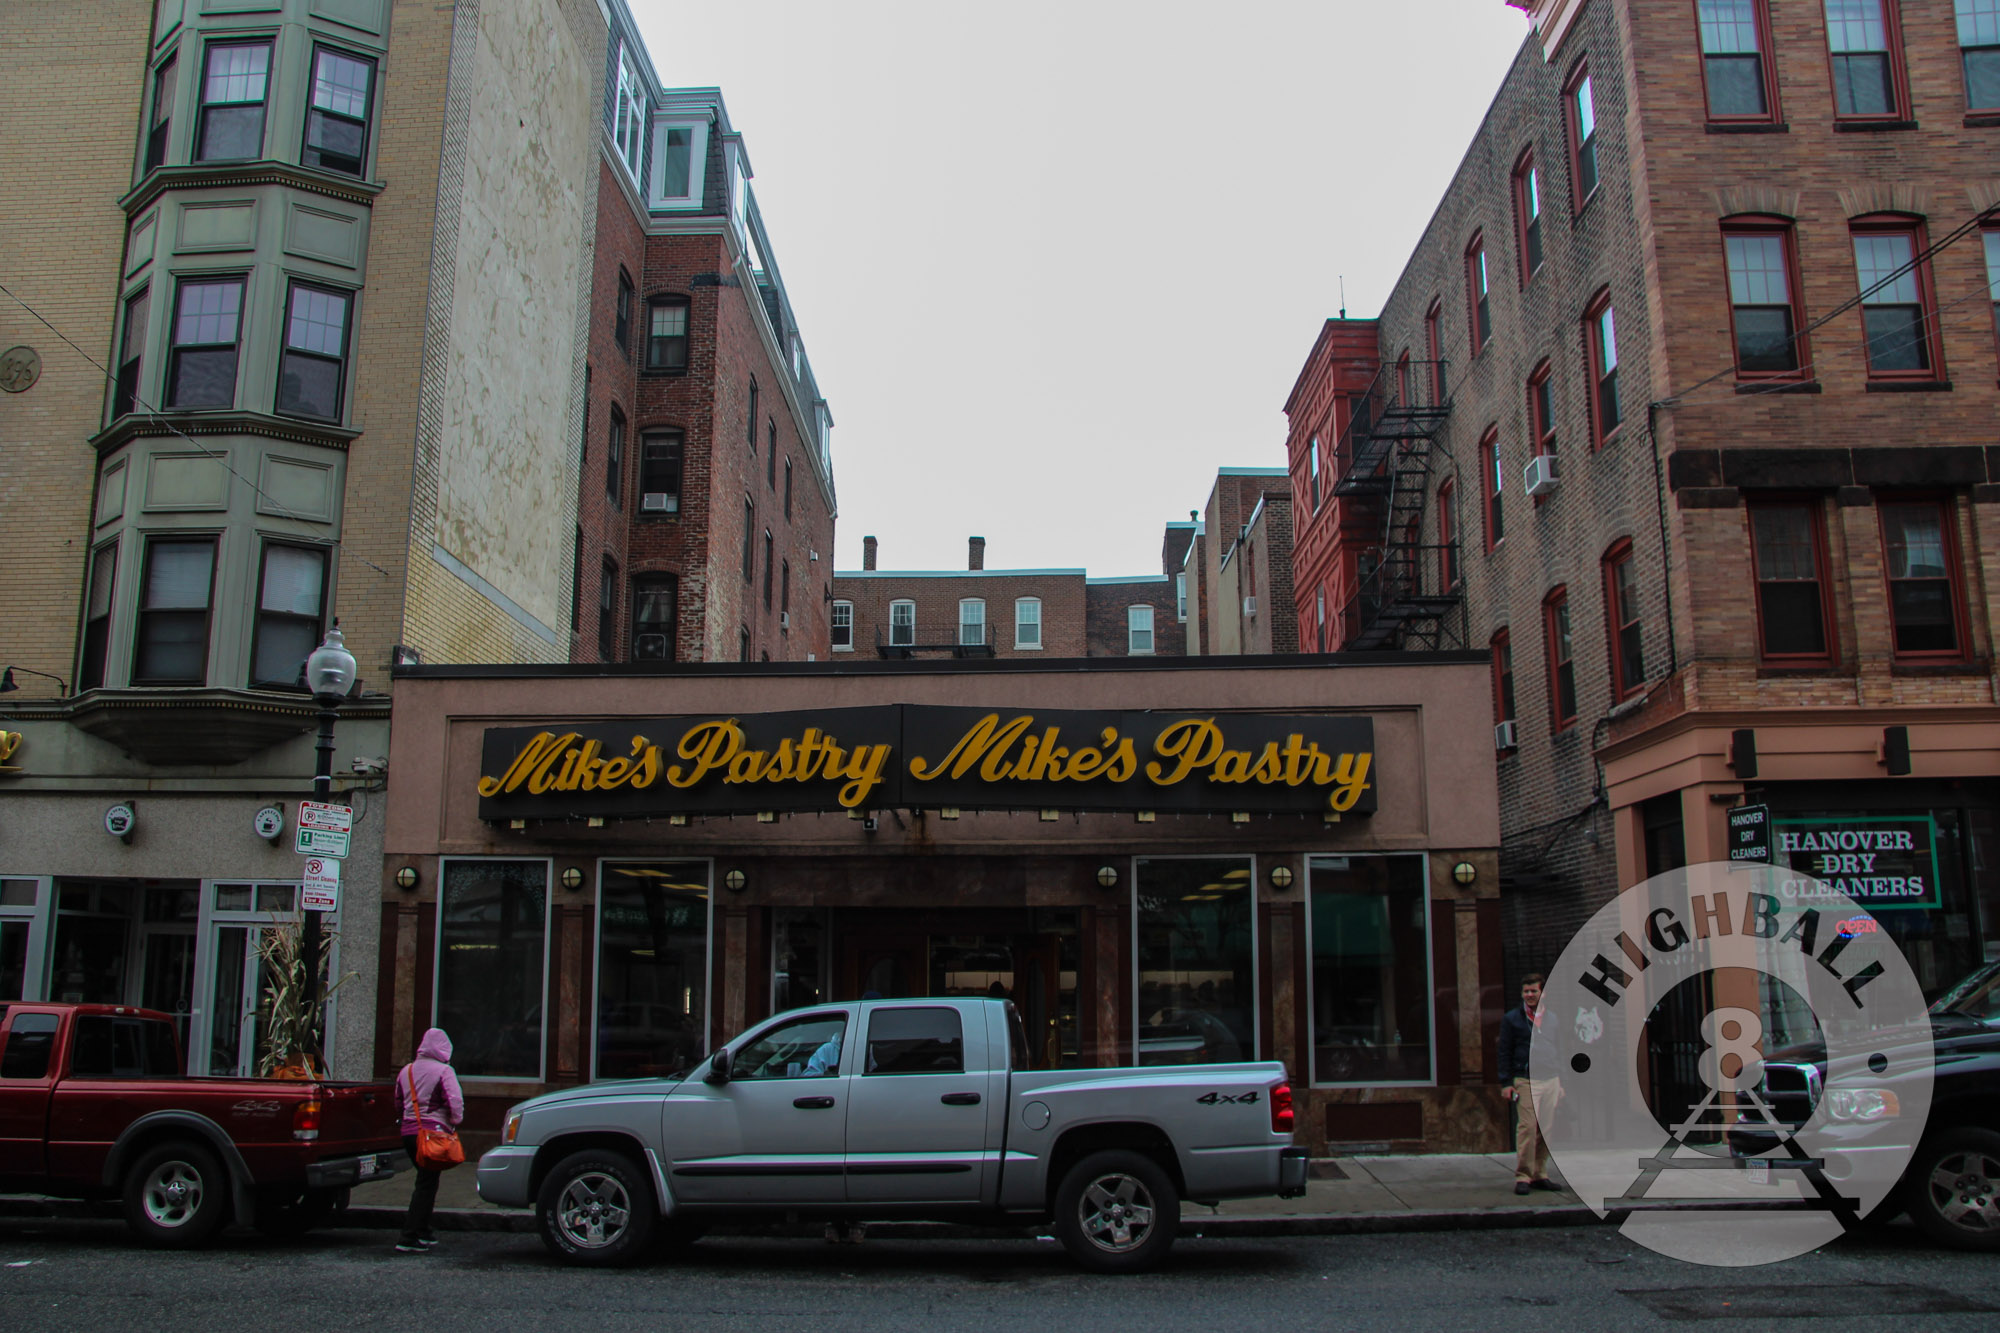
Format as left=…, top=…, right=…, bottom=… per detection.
left=630, top=0, right=1528, bottom=576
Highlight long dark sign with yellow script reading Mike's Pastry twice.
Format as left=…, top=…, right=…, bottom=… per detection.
left=480, top=705, right=1376, bottom=819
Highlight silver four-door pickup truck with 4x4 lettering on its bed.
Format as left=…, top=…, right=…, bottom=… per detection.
left=478, top=999, right=1306, bottom=1273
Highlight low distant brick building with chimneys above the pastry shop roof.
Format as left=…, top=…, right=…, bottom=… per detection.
left=828, top=524, right=1192, bottom=658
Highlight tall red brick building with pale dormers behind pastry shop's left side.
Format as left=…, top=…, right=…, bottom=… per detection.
left=570, top=80, right=834, bottom=662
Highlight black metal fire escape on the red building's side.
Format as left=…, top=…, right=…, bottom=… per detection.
left=1334, top=360, right=1466, bottom=650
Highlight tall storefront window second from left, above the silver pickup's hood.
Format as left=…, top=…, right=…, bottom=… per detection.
left=588, top=861, right=708, bottom=1079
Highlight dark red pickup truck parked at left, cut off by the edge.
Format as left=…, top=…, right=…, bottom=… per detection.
left=0, top=1003, right=406, bottom=1247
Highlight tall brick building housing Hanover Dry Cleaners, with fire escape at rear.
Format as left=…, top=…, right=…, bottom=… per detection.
left=1290, top=0, right=2000, bottom=989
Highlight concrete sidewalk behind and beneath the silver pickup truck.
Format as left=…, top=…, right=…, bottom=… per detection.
left=342, top=1153, right=1596, bottom=1235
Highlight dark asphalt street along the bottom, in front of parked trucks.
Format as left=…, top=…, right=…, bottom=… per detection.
left=0, top=1221, right=2000, bottom=1333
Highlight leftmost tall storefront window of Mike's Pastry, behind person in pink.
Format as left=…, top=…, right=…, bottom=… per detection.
left=436, top=861, right=548, bottom=1079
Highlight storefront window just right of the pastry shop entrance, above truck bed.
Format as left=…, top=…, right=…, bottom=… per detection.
left=1134, top=857, right=1256, bottom=1065
